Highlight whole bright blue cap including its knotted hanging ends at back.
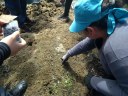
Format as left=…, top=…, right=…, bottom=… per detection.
left=69, top=0, right=128, bottom=35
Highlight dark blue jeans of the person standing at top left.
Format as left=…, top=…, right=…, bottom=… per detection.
left=4, top=0, right=27, bottom=27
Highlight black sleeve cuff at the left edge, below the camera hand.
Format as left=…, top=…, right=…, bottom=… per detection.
left=0, top=42, right=11, bottom=65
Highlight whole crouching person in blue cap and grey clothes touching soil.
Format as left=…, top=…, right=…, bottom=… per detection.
left=62, top=0, right=128, bottom=96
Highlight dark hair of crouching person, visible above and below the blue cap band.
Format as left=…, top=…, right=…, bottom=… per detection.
left=90, top=0, right=123, bottom=30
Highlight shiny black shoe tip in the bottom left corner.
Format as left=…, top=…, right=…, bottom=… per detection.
left=9, top=80, right=27, bottom=96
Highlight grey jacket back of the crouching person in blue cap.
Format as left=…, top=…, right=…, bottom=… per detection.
left=100, top=23, right=128, bottom=94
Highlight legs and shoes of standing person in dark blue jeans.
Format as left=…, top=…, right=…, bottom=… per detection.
left=4, top=0, right=35, bottom=32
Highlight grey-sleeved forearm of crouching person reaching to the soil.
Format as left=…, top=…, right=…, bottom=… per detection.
left=67, top=37, right=95, bottom=56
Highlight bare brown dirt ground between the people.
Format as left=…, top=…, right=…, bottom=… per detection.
left=0, top=0, right=103, bottom=96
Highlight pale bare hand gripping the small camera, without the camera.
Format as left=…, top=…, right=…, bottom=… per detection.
left=0, top=31, right=26, bottom=55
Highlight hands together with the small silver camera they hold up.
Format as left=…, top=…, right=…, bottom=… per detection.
left=0, top=15, right=26, bottom=55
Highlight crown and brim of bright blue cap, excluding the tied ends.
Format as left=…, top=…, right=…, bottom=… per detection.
left=69, top=0, right=103, bottom=32
